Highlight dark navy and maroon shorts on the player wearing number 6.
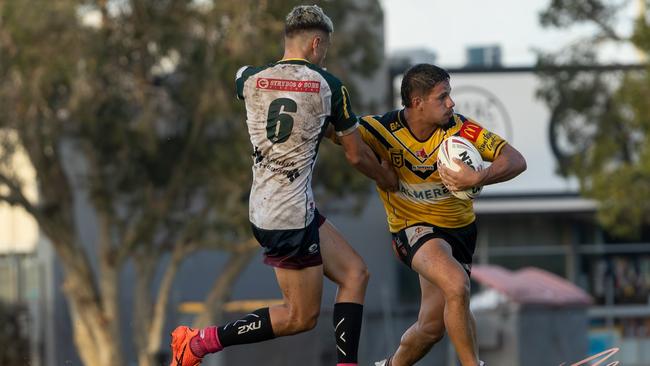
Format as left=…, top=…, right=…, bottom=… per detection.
left=251, top=210, right=326, bottom=269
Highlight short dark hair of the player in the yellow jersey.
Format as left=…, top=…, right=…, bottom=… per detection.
left=400, top=64, right=449, bottom=107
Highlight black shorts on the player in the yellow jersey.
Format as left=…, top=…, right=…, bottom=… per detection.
left=392, top=222, right=476, bottom=275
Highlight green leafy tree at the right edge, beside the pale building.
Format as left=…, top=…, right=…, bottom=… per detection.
left=539, top=0, right=650, bottom=237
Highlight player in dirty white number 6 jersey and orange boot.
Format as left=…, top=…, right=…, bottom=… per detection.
left=171, top=5, right=397, bottom=366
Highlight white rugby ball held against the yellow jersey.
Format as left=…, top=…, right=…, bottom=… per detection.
left=437, top=136, right=483, bottom=200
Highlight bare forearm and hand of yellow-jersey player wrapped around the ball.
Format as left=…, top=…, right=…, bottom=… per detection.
left=438, top=145, right=526, bottom=191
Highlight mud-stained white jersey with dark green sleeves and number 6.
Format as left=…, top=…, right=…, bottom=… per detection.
left=236, top=59, right=358, bottom=230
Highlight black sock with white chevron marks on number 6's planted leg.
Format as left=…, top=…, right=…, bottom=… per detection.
left=334, top=302, right=363, bottom=363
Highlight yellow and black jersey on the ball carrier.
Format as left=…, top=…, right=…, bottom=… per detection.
left=359, top=110, right=506, bottom=233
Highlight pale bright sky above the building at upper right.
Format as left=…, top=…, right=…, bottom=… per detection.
left=380, top=0, right=638, bottom=67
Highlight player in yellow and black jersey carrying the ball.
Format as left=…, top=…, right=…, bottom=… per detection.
left=359, top=64, right=526, bottom=366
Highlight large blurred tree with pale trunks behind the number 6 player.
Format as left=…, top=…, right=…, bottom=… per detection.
left=0, top=0, right=381, bottom=366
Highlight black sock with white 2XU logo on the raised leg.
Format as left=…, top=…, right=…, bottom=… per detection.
left=217, top=308, right=275, bottom=347
